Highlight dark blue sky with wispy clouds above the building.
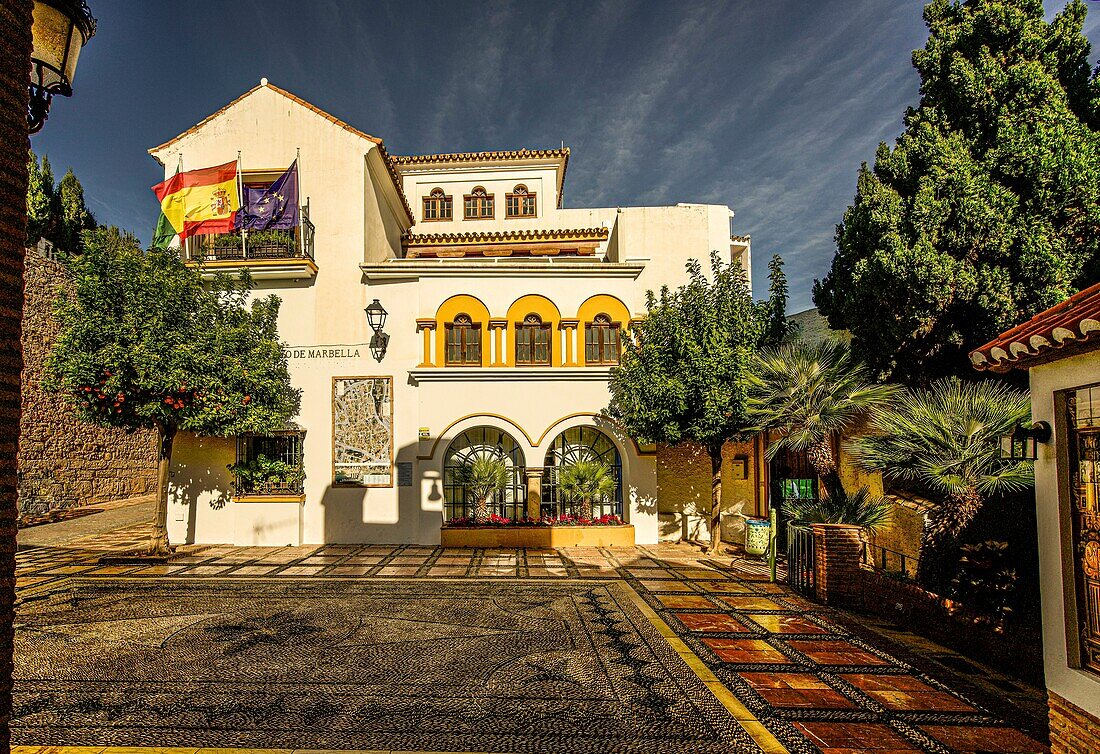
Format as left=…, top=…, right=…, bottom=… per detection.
left=32, top=0, right=1100, bottom=312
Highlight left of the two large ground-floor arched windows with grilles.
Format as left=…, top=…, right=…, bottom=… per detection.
left=443, top=427, right=527, bottom=521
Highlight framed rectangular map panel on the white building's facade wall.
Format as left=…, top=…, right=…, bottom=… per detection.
left=332, top=378, right=394, bottom=487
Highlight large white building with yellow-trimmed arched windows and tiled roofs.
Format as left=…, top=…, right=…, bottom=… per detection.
left=150, top=81, right=763, bottom=545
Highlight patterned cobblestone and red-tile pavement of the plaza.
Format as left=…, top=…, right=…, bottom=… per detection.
left=12, top=526, right=1045, bottom=754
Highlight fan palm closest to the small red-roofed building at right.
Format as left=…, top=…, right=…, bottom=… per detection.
left=846, top=380, right=1034, bottom=540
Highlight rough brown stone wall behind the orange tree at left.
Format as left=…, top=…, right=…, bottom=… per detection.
left=19, top=250, right=156, bottom=515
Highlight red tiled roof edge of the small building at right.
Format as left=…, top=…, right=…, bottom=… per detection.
left=970, top=283, right=1100, bottom=372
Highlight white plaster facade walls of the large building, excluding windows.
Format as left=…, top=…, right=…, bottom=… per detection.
left=157, top=83, right=748, bottom=544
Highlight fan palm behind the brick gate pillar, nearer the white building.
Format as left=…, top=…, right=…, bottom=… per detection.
left=748, top=340, right=899, bottom=494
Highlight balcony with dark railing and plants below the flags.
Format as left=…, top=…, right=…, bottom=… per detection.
left=184, top=214, right=317, bottom=280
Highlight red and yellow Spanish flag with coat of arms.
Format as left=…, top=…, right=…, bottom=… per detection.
left=153, top=161, right=241, bottom=241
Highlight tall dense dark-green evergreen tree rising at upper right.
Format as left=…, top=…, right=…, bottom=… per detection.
left=814, top=0, right=1100, bottom=383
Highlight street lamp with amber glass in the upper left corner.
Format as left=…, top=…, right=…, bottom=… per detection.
left=26, top=0, right=96, bottom=133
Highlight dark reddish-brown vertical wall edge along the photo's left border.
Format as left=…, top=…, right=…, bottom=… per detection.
left=0, top=0, right=32, bottom=752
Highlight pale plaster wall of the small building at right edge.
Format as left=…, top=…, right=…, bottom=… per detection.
left=1031, top=351, right=1100, bottom=717
